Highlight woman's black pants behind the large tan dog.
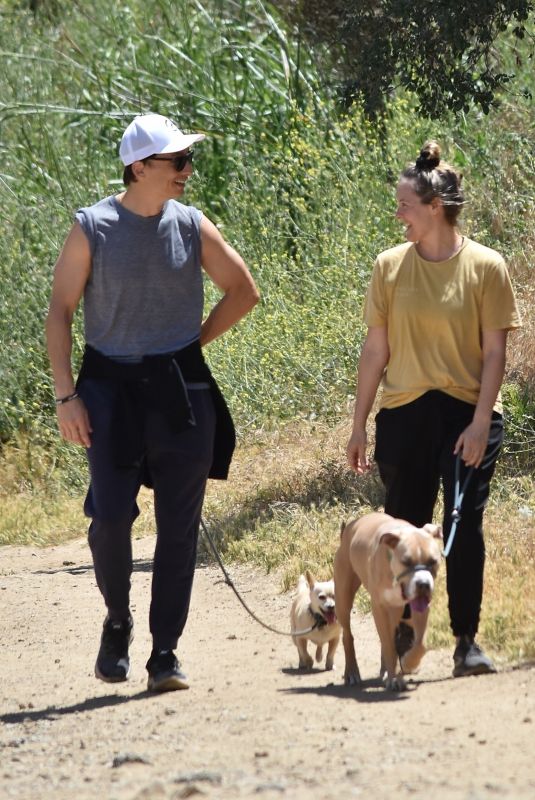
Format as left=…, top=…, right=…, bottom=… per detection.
left=375, top=391, right=503, bottom=636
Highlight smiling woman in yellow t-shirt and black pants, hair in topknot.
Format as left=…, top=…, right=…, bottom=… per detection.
left=347, top=141, right=520, bottom=677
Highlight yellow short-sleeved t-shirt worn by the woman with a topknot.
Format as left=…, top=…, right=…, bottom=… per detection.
left=364, top=238, right=521, bottom=412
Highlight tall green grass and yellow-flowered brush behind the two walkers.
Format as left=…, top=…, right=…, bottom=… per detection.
left=0, top=0, right=535, bottom=506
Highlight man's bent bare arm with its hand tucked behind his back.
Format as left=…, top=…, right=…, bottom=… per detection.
left=201, top=217, right=259, bottom=346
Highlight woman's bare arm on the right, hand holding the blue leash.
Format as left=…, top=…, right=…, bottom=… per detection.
left=454, top=330, right=507, bottom=467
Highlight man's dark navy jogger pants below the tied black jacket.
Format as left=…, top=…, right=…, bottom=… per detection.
left=79, top=379, right=215, bottom=650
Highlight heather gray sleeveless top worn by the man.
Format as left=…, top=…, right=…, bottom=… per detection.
left=75, top=196, right=203, bottom=359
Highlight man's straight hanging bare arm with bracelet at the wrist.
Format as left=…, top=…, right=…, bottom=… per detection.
left=46, top=223, right=91, bottom=447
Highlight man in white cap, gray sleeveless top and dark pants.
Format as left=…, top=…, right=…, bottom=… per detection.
left=46, top=114, right=258, bottom=691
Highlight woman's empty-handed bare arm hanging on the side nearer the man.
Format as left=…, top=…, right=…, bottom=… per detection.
left=347, top=326, right=390, bottom=474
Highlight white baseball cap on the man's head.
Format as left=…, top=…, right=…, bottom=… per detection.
left=119, top=114, right=206, bottom=166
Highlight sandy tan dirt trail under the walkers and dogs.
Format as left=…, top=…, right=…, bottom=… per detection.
left=0, top=537, right=535, bottom=800
